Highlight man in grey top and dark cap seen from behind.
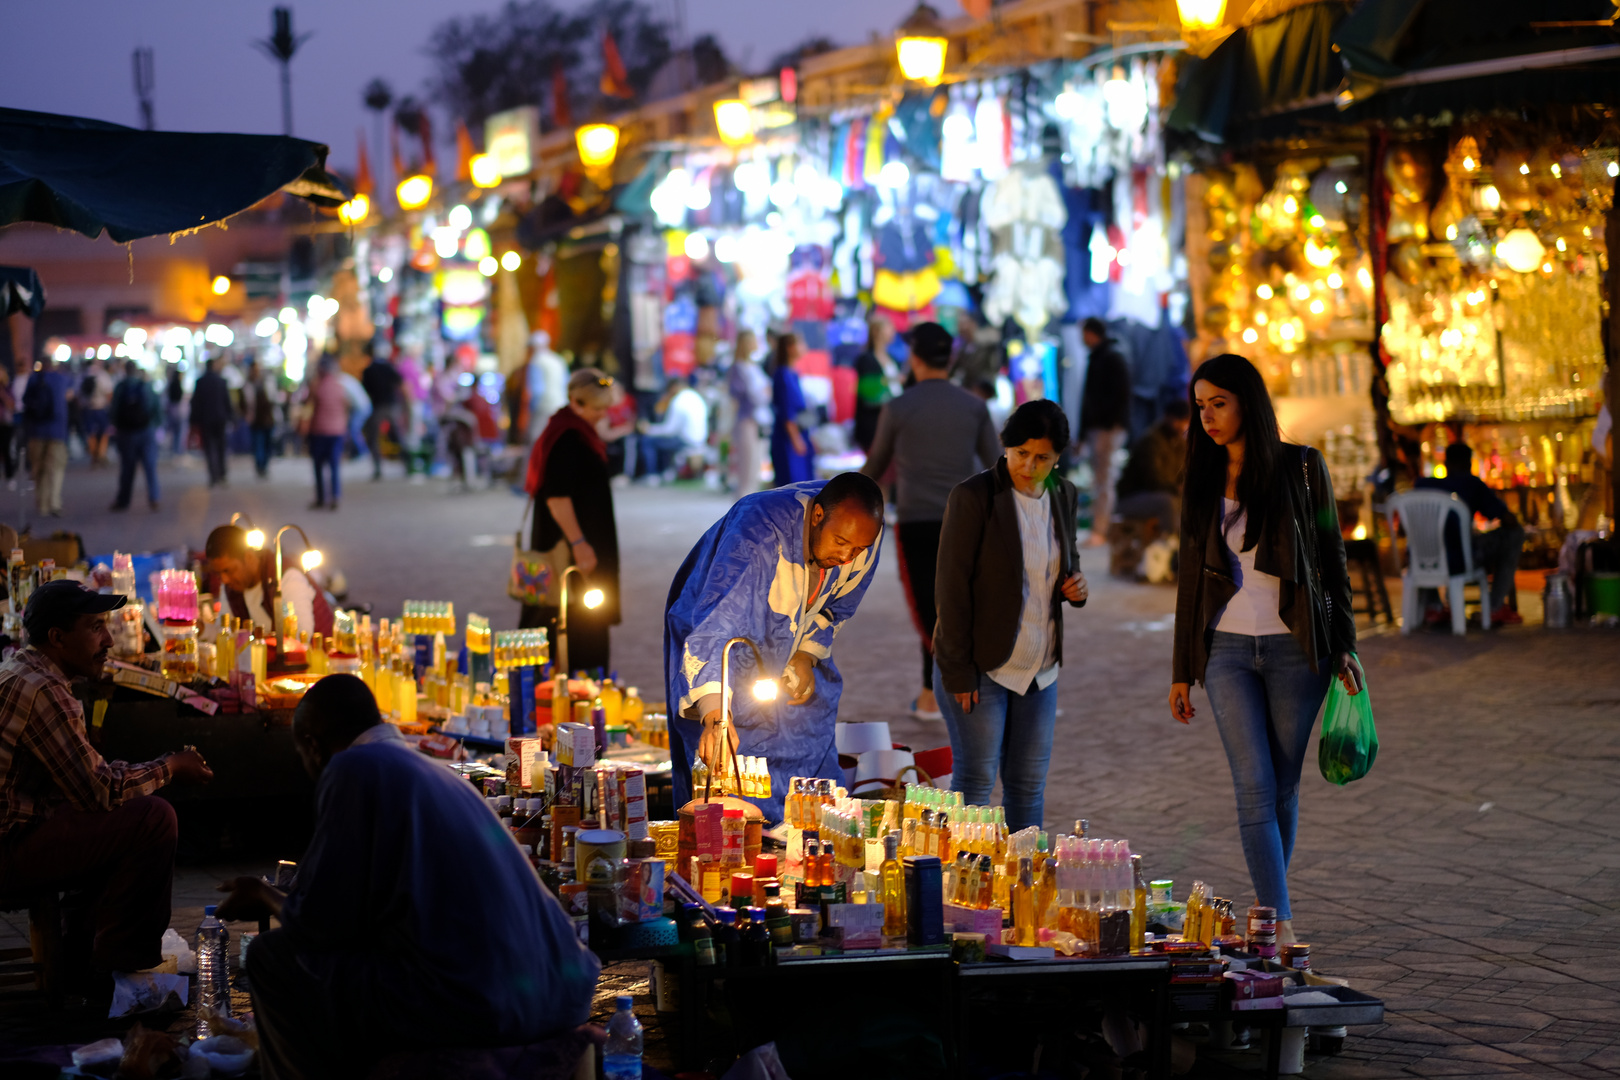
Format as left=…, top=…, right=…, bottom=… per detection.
left=860, top=322, right=1001, bottom=721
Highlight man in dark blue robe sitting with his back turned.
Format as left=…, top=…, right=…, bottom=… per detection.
left=219, top=675, right=601, bottom=1080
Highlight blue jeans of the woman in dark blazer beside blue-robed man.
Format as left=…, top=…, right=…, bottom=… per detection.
left=933, top=664, right=1058, bottom=832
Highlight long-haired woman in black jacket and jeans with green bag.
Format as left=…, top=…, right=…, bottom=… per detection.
left=1170, top=353, right=1364, bottom=942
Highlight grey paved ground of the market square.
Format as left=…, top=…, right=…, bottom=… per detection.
left=0, top=446, right=1620, bottom=1080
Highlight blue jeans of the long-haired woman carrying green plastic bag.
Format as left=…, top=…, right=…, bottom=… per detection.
left=1204, top=630, right=1332, bottom=918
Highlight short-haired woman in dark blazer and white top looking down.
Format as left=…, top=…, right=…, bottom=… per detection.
left=933, top=400, right=1087, bottom=832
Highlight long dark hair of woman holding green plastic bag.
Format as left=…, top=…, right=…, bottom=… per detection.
left=1181, top=353, right=1288, bottom=551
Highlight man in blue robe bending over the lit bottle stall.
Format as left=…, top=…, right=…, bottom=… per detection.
left=664, top=473, right=883, bottom=821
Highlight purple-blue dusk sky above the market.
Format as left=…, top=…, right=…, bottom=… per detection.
left=0, top=0, right=939, bottom=168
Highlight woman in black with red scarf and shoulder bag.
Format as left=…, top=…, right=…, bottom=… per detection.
left=518, top=368, right=619, bottom=670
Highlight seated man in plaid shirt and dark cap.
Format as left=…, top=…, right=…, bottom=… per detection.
left=0, top=581, right=214, bottom=986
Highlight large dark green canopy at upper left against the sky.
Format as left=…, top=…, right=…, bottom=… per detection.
left=0, top=108, right=347, bottom=243
